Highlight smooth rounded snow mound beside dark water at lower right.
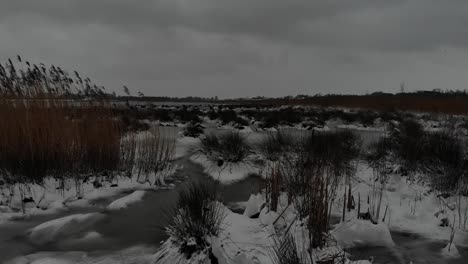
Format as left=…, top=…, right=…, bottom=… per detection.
left=332, top=219, right=395, bottom=248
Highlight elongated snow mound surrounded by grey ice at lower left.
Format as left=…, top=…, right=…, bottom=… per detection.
left=29, top=213, right=104, bottom=244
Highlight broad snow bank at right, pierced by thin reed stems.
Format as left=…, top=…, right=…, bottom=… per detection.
left=332, top=164, right=468, bottom=247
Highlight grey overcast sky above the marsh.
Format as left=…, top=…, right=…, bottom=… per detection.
left=0, top=0, right=468, bottom=98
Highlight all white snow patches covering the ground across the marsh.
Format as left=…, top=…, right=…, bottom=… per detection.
left=0, top=112, right=468, bottom=264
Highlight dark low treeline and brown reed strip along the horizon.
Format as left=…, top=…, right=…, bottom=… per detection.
left=113, top=89, right=468, bottom=114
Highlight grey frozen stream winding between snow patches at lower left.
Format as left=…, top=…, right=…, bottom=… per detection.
left=0, top=159, right=259, bottom=263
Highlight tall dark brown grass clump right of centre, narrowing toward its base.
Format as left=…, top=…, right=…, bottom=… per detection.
left=281, top=131, right=359, bottom=248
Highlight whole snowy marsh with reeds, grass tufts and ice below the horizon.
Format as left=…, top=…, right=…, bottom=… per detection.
left=0, top=59, right=468, bottom=264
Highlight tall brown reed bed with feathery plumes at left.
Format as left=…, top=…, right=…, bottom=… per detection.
left=0, top=56, right=121, bottom=206
